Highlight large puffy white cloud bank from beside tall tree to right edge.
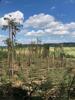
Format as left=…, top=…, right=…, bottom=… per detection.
left=22, top=13, right=75, bottom=36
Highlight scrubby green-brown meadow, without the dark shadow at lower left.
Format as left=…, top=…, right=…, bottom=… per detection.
left=0, top=45, right=75, bottom=100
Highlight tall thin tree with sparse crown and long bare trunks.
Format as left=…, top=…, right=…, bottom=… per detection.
left=3, top=16, right=21, bottom=77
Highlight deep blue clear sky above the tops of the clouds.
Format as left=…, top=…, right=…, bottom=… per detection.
left=0, top=0, right=75, bottom=22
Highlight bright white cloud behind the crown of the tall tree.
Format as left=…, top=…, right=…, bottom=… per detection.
left=0, top=11, right=24, bottom=27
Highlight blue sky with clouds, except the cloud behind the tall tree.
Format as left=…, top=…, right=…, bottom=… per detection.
left=0, top=0, right=75, bottom=45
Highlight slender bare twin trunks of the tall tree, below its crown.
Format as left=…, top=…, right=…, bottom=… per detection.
left=8, top=25, right=14, bottom=78
